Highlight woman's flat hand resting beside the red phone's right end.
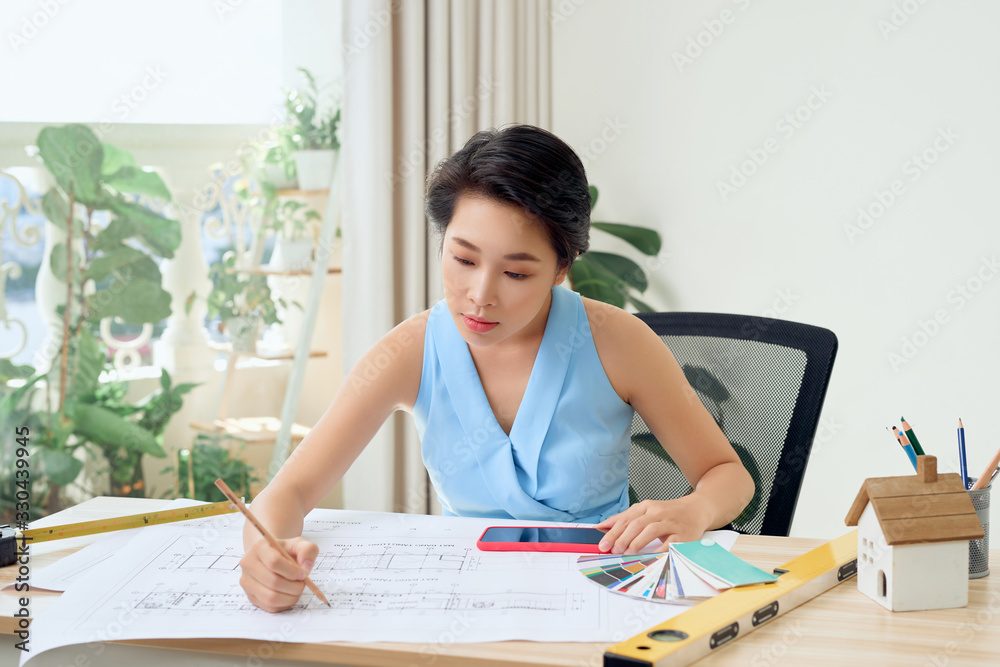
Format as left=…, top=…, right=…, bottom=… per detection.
left=597, top=494, right=712, bottom=554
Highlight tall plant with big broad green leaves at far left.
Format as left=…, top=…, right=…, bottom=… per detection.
left=0, top=124, right=194, bottom=512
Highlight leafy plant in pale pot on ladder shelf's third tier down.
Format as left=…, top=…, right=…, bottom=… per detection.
left=185, top=251, right=286, bottom=352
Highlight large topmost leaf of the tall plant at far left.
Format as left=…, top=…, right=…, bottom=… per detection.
left=38, top=124, right=106, bottom=208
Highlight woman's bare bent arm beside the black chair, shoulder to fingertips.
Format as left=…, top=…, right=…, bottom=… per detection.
left=588, top=306, right=754, bottom=553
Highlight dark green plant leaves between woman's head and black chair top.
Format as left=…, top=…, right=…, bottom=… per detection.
left=568, top=185, right=662, bottom=312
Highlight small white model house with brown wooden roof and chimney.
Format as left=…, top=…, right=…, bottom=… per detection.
left=845, top=456, right=984, bottom=611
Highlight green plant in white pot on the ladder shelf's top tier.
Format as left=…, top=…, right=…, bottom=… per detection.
left=285, top=67, right=340, bottom=191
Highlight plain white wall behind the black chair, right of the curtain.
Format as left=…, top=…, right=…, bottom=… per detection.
left=552, top=0, right=1000, bottom=548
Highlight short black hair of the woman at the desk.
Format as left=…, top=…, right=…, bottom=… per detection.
left=424, top=125, right=590, bottom=268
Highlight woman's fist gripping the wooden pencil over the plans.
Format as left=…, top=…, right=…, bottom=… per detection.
left=240, top=537, right=319, bottom=613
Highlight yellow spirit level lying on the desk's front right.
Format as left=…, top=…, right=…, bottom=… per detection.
left=604, top=530, right=858, bottom=667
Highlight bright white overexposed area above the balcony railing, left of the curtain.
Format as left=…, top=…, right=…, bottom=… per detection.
left=0, top=0, right=341, bottom=124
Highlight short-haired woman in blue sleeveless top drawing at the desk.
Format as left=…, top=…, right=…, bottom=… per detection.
left=240, top=125, right=753, bottom=611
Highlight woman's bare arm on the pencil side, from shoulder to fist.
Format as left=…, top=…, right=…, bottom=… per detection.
left=240, top=313, right=427, bottom=611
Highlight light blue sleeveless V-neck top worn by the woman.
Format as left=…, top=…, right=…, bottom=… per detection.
left=413, top=286, right=634, bottom=523
